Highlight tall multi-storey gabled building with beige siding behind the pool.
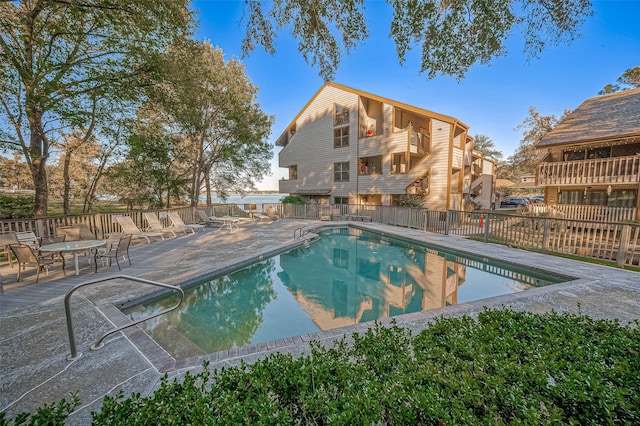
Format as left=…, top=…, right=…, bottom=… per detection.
left=276, top=82, right=495, bottom=210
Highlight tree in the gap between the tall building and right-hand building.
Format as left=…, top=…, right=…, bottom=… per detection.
left=500, top=107, right=570, bottom=182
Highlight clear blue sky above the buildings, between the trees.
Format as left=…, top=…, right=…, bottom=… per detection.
left=193, top=0, right=640, bottom=190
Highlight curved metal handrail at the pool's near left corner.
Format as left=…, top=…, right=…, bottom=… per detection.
left=64, top=275, right=184, bottom=361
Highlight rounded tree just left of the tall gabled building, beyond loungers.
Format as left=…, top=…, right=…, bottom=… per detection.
left=149, top=39, right=273, bottom=206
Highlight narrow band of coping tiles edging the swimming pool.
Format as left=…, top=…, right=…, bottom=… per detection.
left=107, top=224, right=575, bottom=371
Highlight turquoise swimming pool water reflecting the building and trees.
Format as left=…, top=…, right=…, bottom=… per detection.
left=124, top=228, right=567, bottom=358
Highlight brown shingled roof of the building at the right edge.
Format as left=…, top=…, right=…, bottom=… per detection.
left=537, top=88, right=640, bottom=148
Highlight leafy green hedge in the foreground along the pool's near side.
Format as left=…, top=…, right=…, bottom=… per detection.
left=2, top=310, right=640, bottom=425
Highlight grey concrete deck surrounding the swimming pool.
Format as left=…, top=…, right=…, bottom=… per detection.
left=0, top=220, right=640, bottom=425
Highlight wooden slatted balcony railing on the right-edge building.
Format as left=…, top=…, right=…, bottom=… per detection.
left=538, top=155, right=640, bottom=186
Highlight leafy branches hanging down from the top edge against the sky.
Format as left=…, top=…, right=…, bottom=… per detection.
left=243, top=0, right=592, bottom=80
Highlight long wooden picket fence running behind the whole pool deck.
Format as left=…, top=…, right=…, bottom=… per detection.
left=0, top=204, right=640, bottom=267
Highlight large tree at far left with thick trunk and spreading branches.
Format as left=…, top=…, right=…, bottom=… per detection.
left=0, top=0, right=191, bottom=216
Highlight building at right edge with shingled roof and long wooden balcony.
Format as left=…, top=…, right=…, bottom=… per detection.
left=537, top=89, right=640, bottom=219
